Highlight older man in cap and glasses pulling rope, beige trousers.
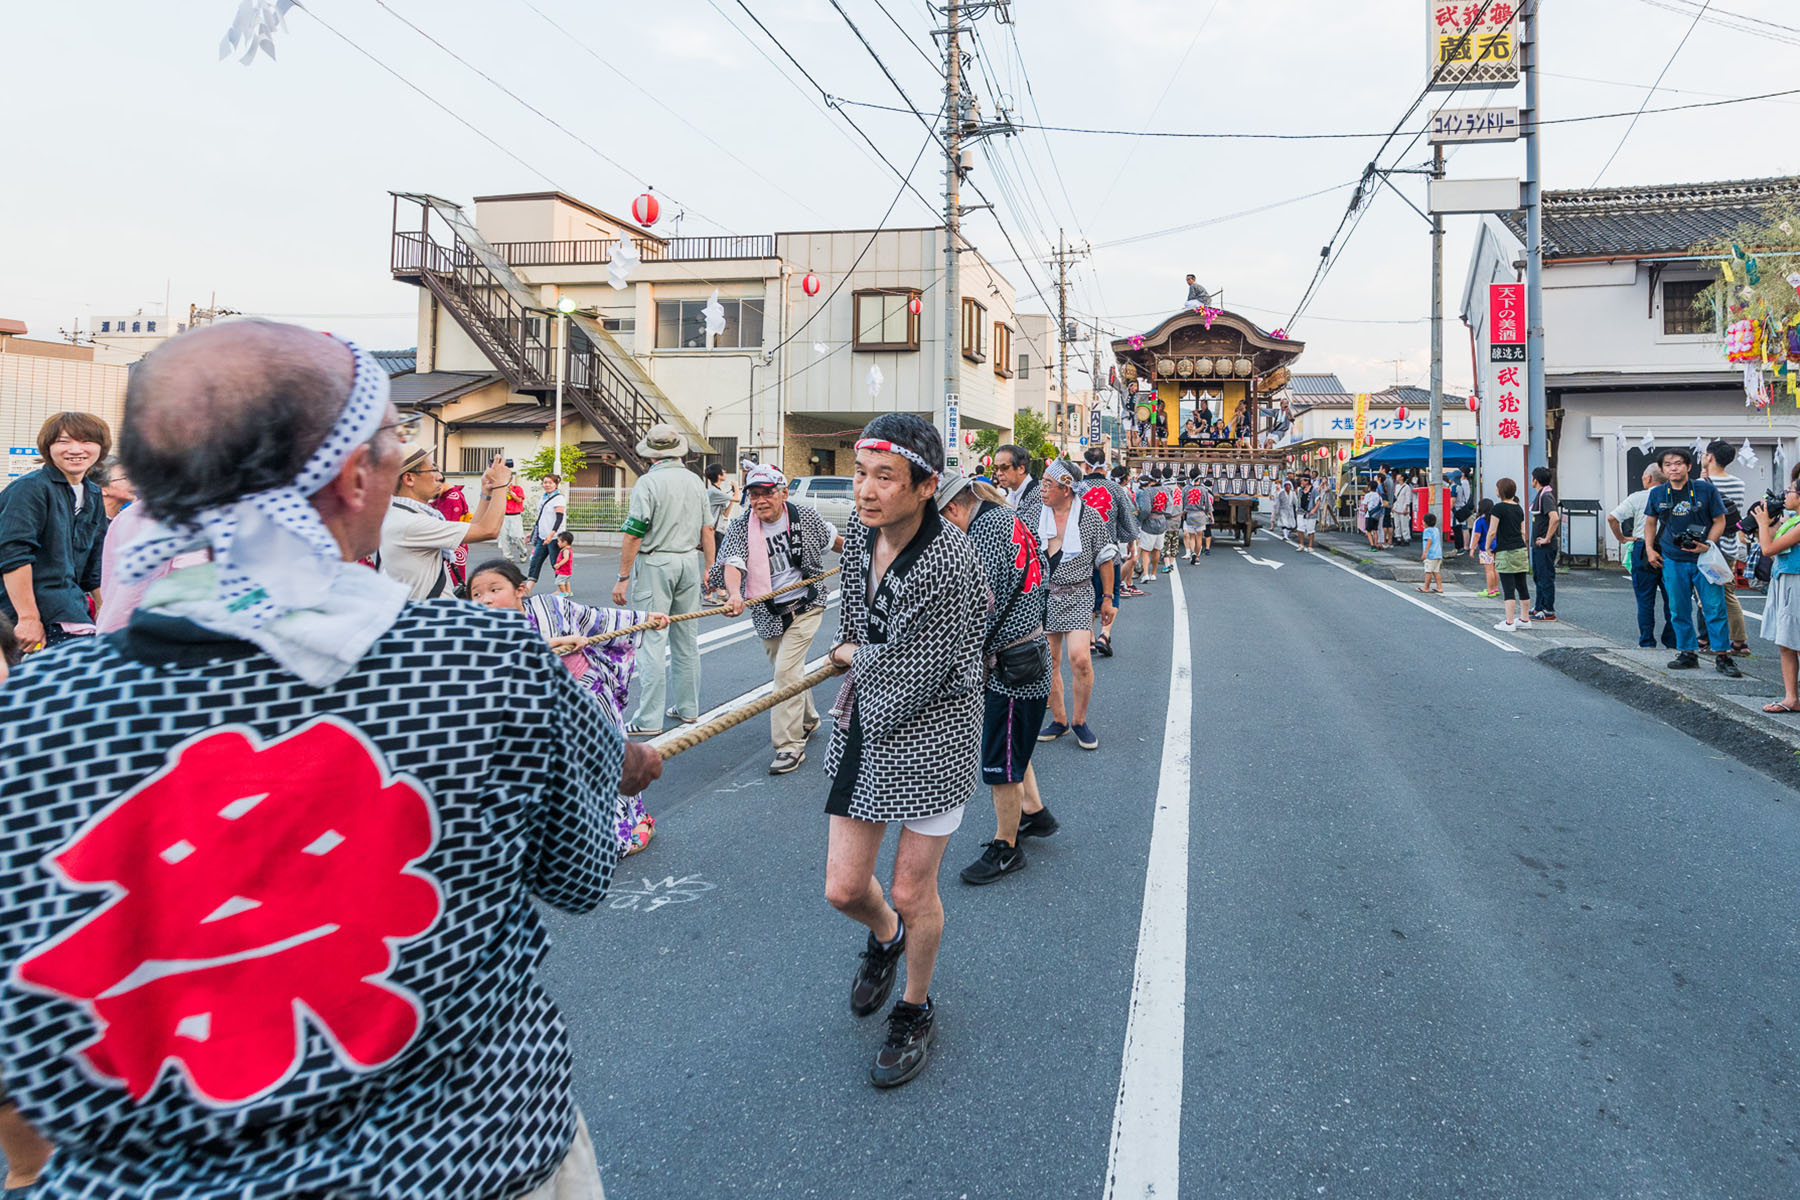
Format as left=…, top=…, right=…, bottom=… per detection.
left=707, top=462, right=844, bottom=775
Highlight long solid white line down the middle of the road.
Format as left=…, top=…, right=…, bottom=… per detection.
left=1105, top=570, right=1193, bottom=1200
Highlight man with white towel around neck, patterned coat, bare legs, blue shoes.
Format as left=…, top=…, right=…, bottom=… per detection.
left=1037, top=461, right=1118, bottom=750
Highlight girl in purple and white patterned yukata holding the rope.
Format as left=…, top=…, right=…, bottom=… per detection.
left=468, top=558, right=670, bottom=855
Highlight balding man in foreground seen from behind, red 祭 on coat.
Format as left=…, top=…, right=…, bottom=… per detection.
left=0, top=320, right=661, bottom=1200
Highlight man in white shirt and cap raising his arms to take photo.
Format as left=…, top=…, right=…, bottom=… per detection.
left=376, top=446, right=513, bottom=599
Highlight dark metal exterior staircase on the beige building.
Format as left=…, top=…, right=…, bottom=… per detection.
left=391, top=193, right=711, bottom=475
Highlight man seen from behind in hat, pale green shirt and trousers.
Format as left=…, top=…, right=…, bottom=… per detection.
left=612, top=425, right=713, bottom=736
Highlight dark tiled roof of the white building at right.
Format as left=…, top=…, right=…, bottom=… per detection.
left=1499, top=176, right=1800, bottom=259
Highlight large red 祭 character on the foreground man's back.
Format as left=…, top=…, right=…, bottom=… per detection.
left=14, top=718, right=443, bottom=1106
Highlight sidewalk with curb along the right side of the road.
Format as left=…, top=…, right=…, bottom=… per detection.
left=1318, top=529, right=1800, bottom=788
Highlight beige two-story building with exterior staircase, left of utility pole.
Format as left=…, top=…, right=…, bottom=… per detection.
left=392, top=193, right=1019, bottom=488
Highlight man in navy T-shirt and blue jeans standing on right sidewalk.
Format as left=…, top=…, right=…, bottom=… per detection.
left=1643, top=446, right=1744, bottom=678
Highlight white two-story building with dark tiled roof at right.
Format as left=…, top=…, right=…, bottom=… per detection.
left=1462, top=176, right=1800, bottom=558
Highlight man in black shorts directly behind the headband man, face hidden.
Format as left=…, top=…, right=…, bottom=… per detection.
left=938, top=471, right=1057, bottom=885
